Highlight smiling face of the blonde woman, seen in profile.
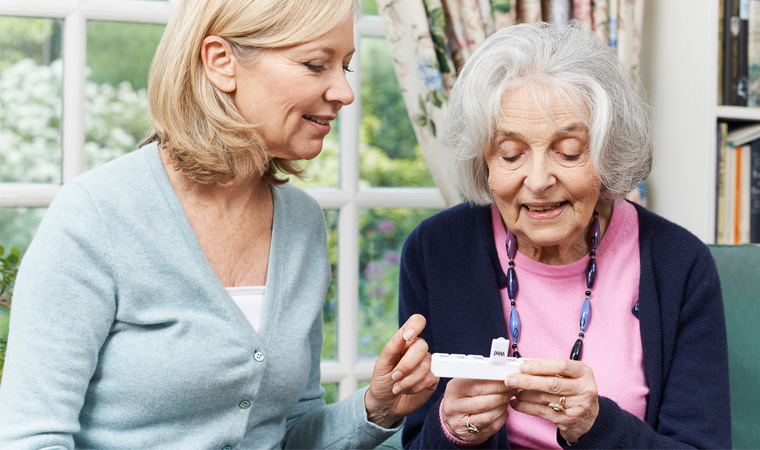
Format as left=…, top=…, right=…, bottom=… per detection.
left=233, top=16, right=354, bottom=160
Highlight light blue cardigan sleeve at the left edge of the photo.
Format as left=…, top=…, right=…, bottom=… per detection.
left=0, top=183, right=116, bottom=449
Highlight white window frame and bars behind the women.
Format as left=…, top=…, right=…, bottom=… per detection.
left=0, top=0, right=445, bottom=400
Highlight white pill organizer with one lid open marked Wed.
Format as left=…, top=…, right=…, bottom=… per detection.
left=430, top=338, right=529, bottom=380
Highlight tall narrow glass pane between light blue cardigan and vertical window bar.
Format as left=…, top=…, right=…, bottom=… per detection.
left=322, top=209, right=338, bottom=361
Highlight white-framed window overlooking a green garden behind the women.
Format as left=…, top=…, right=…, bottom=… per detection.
left=0, top=0, right=444, bottom=400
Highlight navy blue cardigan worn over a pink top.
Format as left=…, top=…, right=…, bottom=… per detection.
left=399, top=203, right=731, bottom=449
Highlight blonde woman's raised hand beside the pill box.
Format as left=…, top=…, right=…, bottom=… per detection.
left=364, top=314, right=438, bottom=428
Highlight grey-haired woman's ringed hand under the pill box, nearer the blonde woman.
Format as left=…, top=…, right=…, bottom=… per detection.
left=441, top=378, right=515, bottom=444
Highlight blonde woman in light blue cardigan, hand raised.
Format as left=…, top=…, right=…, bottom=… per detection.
left=0, top=0, right=437, bottom=449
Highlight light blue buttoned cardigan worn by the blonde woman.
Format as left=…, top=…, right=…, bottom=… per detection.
left=0, top=144, right=399, bottom=450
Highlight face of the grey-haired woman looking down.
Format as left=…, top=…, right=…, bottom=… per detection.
left=486, top=88, right=601, bottom=253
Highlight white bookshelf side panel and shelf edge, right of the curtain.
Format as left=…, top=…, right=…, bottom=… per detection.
left=641, top=0, right=760, bottom=243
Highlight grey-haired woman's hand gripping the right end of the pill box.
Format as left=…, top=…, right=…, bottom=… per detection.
left=505, top=358, right=599, bottom=443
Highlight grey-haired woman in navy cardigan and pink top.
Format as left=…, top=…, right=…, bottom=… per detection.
left=400, top=24, right=731, bottom=448
